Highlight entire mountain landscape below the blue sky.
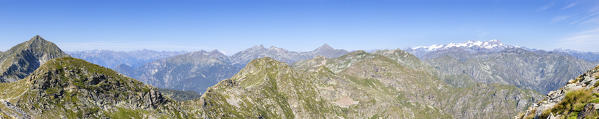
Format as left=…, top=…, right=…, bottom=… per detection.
left=0, top=36, right=599, bottom=118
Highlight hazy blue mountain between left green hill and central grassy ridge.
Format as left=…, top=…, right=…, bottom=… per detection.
left=134, top=50, right=242, bottom=93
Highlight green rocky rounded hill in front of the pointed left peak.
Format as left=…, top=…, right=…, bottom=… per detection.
left=0, top=57, right=186, bottom=118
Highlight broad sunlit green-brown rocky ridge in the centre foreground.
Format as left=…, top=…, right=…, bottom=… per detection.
left=186, top=50, right=540, bottom=118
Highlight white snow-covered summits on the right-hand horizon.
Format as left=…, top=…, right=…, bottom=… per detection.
left=408, top=40, right=516, bottom=51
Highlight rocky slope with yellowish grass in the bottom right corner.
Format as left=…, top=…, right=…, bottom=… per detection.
left=516, top=67, right=599, bottom=119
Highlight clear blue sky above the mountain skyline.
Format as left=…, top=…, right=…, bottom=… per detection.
left=0, top=0, right=599, bottom=53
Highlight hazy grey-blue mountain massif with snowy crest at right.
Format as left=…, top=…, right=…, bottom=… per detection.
left=407, top=40, right=593, bottom=93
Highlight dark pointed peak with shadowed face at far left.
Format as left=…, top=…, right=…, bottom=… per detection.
left=0, top=36, right=69, bottom=82
